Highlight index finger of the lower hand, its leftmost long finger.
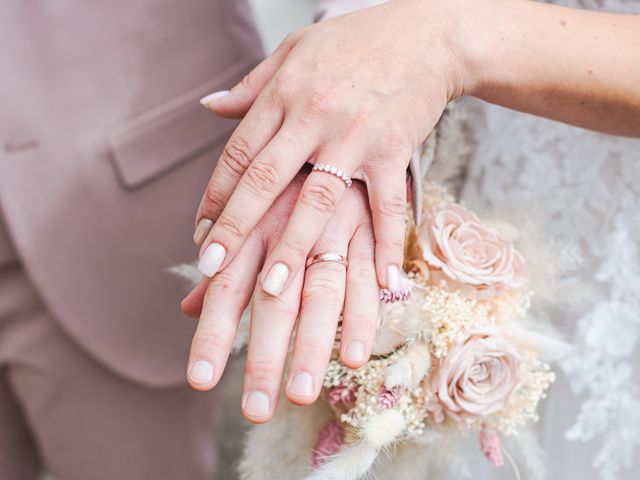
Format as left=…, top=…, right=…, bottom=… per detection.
left=187, top=236, right=264, bottom=391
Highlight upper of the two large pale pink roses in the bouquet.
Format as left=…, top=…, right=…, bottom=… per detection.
left=418, top=204, right=528, bottom=294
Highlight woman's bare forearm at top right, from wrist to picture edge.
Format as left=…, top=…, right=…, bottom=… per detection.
left=459, top=0, right=640, bottom=136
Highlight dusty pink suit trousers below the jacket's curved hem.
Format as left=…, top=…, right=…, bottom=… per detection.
left=0, top=264, right=216, bottom=480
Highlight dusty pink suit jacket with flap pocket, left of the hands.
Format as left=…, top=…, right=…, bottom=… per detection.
left=0, top=0, right=263, bottom=386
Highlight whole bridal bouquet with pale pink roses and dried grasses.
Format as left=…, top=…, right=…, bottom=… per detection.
left=234, top=162, right=568, bottom=480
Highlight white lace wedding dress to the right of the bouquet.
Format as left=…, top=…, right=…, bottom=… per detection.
left=461, top=0, right=640, bottom=480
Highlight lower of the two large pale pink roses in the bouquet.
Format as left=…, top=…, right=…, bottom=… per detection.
left=432, top=329, right=520, bottom=423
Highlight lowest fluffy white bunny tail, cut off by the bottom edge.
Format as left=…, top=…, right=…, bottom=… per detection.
left=306, top=442, right=378, bottom=480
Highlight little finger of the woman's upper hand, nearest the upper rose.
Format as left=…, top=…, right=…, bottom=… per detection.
left=367, top=162, right=407, bottom=292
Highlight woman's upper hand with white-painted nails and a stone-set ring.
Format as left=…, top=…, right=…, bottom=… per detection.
left=196, top=0, right=464, bottom=295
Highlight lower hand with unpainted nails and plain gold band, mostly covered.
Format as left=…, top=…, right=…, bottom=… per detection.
left=182, top=175, right=379, bottom=423
